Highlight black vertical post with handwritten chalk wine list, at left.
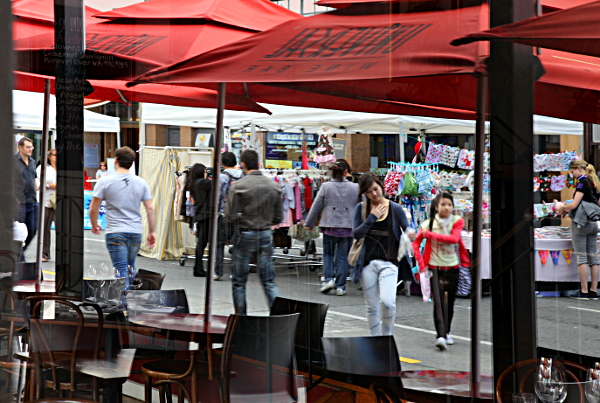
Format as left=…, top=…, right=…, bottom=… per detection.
left=54, top=0, right=85, bottom=297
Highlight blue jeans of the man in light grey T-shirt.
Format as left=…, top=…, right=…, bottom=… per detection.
left=106, top=232, right=142, bottom=290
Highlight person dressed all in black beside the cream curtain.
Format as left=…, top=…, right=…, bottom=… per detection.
left=187, top=164, right=211, bottom=277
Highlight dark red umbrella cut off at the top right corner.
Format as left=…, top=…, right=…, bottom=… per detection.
left=452, top=1, right=600, bottom=58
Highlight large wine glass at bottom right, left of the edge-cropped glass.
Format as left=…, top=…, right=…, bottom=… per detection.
left=534, top=357, right=567, bottom=403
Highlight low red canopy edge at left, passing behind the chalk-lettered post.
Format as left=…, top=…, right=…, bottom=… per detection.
left=14, top=71, right=270, bottom=113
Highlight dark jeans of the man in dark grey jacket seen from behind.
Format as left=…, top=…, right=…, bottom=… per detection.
left=231, top=230, right=279, bottom=315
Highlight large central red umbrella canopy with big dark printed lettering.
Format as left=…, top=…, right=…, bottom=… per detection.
left=136, top=6, right=487, bottom=83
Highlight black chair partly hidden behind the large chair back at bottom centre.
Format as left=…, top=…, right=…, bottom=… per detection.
left=270, top=297, right=329, bottom=390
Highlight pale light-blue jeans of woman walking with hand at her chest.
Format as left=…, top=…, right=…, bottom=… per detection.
left=360, top=260, right=398, bottom=336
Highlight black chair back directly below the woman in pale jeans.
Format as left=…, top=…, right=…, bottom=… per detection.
left=321, top=336, right=406, bottom=399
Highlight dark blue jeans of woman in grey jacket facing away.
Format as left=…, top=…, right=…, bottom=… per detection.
left=323, top=234, right=352, bottom=289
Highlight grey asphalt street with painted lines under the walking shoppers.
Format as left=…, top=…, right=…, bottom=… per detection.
left=26, top=231, right=600, bottom=374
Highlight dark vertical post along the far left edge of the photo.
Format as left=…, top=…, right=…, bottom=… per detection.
left=0, top=0, right=19, bottom=272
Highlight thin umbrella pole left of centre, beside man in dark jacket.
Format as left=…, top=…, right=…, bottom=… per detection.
left=205, top=83, right=225, bottom=322
